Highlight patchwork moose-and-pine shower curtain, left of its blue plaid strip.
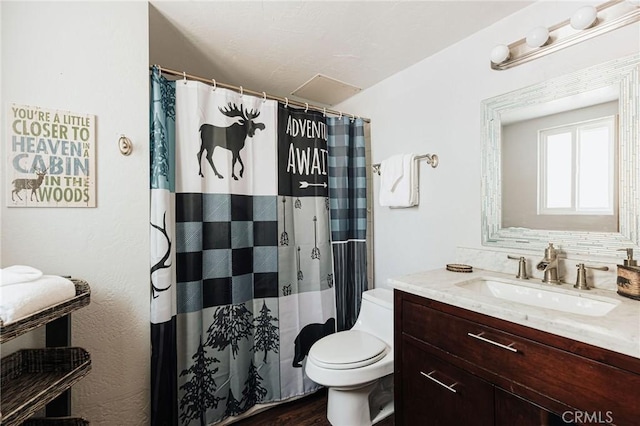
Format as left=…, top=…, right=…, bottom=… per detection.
left=150, top=68, right=344, bottom=425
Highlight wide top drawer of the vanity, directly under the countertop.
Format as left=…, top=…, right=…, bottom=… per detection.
left=402, top=300, right=640, bottom=425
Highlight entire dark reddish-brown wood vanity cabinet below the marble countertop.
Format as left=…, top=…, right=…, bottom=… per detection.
left=394, top=290, right=640, bottom=426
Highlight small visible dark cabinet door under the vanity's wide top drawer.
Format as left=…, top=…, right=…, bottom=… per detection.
left=494, top=388, right=575, bottom=426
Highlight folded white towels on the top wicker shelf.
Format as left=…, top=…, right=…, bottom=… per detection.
left=0, top=275, right=76, bottom=325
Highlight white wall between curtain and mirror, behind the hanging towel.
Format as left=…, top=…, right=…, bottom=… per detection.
left=337, top=2, right=640, bottom=286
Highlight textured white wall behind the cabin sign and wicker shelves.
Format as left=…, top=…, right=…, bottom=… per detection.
left=0, top=1, right=150, bottom=425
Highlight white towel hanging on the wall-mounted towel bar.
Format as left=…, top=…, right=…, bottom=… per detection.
left=379, top=154, right=418, bottom=207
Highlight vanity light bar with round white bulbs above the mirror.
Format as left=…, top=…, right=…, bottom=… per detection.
left=490, top=0, right=640, bottom=70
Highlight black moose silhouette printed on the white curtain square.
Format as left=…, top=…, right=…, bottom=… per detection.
left=198, top=102, right=265, bottom=180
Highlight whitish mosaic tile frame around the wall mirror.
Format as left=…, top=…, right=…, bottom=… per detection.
left=481, top=54, right=640, bottom=257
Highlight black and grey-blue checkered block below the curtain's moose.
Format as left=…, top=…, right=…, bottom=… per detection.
left=176, top=193, right=278, bottom=313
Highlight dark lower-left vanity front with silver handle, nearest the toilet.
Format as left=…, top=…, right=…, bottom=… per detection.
left=396, top=340, right=494, bottom=426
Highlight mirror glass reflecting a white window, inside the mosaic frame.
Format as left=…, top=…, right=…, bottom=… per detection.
left=501, top=101, right=618, bottom=232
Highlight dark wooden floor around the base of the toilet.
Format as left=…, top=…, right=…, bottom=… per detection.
left=234, top=389, right=394, bottom=426
